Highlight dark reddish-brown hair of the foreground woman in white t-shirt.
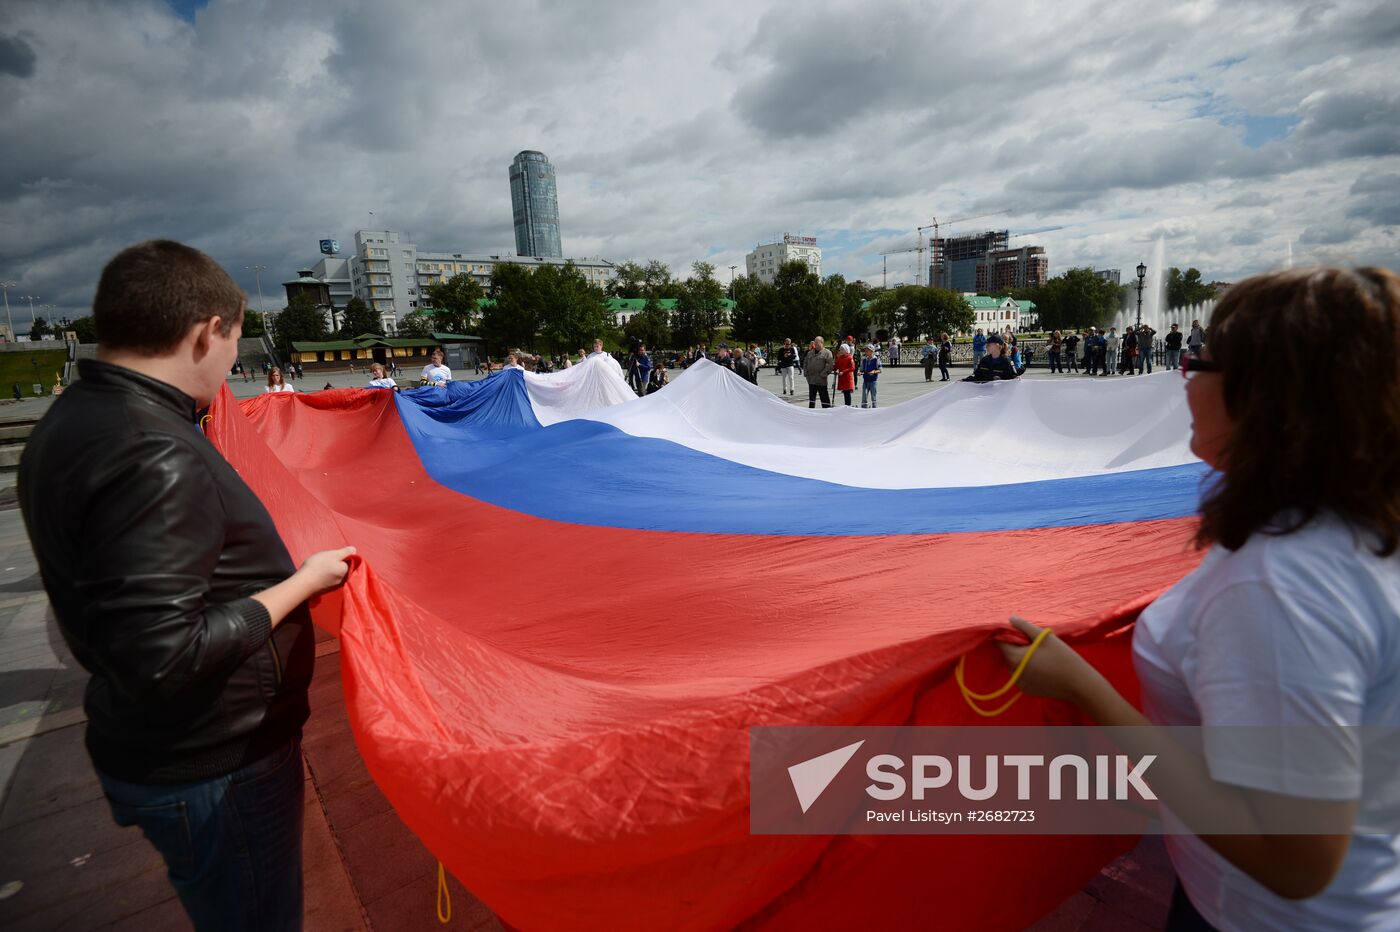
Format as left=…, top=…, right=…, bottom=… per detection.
left=1196, top=269, right=1400, bottom=557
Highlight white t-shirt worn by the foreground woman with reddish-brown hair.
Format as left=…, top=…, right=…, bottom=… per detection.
left=1133, top=518, right=1400, bottom=931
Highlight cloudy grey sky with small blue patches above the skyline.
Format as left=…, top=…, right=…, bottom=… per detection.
left=0, top=0, right=1400, bottom=321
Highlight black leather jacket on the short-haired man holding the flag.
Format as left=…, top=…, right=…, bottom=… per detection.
left=20, top=360, right=315, bottom=784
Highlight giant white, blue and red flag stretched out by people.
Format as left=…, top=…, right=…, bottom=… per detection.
left=210, top=357, right=1205, bottom=929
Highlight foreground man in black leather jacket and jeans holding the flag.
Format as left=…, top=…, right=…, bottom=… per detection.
left=20, top=241, right=354, bottom=929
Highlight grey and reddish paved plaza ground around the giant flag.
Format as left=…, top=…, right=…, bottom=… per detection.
left=0, top=367, right=1172, bottom=932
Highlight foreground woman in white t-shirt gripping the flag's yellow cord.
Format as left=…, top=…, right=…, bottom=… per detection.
left=1002, top=269, right=1400, bottom=929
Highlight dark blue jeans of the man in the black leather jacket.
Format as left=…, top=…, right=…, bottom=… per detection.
left=98, top=740, right=304, bottom=932
